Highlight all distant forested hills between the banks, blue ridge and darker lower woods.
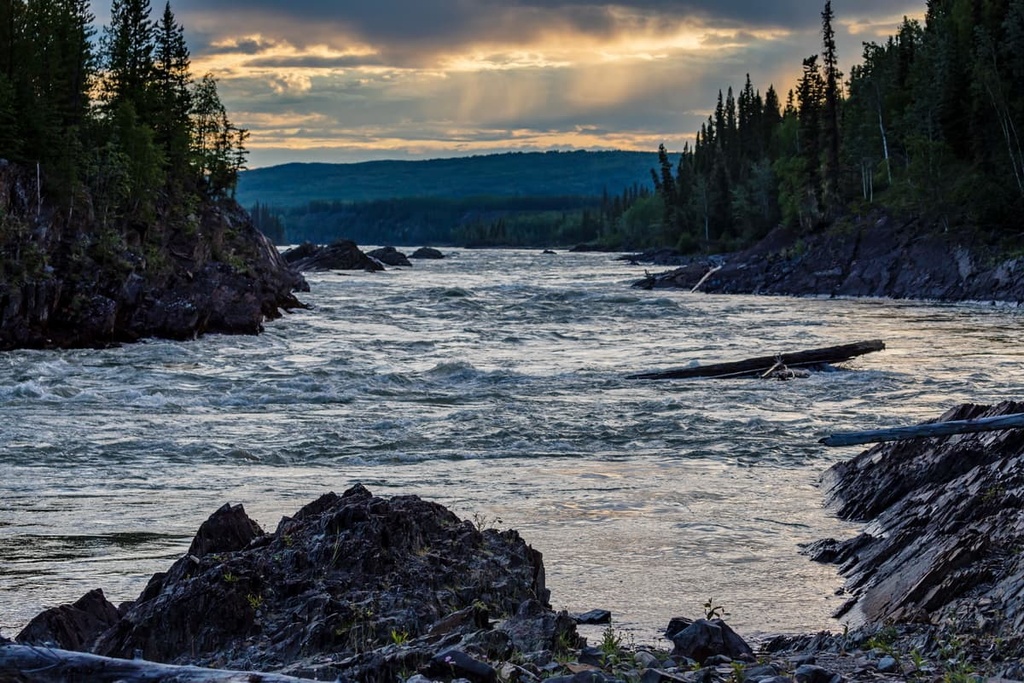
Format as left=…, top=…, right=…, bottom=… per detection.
left=239, top=152, right=657, bottom=247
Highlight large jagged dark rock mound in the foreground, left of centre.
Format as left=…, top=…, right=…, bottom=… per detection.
left=45, top=485, right=557, bottom=681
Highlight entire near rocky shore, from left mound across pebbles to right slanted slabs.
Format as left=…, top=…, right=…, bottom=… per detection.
left=0, top=402, right=1024, bottom=683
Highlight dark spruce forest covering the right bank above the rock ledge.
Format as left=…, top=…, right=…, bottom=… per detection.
left=650, top=0, right=1024, bottom=251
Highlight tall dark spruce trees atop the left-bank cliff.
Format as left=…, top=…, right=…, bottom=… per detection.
left=0, top=0, right=248, bottom=280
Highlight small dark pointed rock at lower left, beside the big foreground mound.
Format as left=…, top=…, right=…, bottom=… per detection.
left=15, top=588, right=121, bottom=650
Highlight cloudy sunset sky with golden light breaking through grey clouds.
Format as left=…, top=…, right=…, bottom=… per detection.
left=93, top=0, right=925, bottom=168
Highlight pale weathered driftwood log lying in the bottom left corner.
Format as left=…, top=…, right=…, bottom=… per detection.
left=0, top=643, right=308, bottom=683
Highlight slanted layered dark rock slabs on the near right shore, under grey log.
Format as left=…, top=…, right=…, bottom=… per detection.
left=816, top=401, right=1024, bottom=634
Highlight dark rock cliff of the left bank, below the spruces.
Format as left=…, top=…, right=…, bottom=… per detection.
left=0, top=162, right=308, bottom=350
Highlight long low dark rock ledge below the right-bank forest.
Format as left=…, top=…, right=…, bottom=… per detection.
left=634, top=216, right=1024, bottom=303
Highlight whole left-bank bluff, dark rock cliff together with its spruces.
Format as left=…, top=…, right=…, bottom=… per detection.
left=0, top=0, right=297, bottom=348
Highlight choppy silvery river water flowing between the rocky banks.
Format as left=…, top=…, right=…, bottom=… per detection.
left=0, top=251, right=1024, bottom=641
